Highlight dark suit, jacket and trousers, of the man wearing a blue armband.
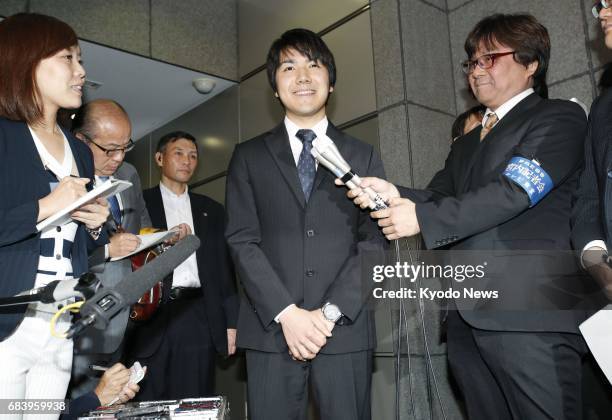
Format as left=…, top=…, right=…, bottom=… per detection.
left=401, top=94, right=586, bottom=419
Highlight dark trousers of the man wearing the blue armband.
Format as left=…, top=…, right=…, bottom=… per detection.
left=447, top=311, right=586, bottom=420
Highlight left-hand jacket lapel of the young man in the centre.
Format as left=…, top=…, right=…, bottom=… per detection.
left=265, top=123, right=314, bottom=207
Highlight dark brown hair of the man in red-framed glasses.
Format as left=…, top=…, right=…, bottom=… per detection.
left=465, top=13, right=550, bottom=98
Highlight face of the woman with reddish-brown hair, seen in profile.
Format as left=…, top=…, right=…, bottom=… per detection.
left=35, top=45, right=85, bottom=115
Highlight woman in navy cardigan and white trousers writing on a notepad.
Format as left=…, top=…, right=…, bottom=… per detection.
left=0, top=13, right=109, bottom=418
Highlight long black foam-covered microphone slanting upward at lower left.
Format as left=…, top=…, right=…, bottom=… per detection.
left=67, top=235, right=200, bottom=338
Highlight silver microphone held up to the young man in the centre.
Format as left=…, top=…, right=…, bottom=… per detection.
left=310, top=136, right=388, bottom=210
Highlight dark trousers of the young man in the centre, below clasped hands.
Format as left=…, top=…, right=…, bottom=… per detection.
left=246, top=350, right=372, bottom=420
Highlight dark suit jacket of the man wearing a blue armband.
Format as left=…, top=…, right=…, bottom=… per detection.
left=400, top=93, right=591, bottom=333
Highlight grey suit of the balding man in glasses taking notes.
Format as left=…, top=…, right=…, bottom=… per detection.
left=70, top=162, right=152, bottom=398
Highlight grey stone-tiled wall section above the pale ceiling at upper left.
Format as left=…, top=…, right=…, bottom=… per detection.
left=0, top=0, right=238, bottom=80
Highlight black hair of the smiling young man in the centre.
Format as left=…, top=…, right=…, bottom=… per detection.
left=266, top=28, right=336, bottom=92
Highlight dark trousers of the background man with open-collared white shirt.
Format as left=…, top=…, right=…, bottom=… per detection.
left=129, top=298, right=216, bottom=401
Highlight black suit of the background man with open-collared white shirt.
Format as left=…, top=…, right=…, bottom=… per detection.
left=127, top=186, right=238, bottom=400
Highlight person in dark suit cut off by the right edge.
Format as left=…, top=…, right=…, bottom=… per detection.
left=572, top=1, right=612, bottom=299
